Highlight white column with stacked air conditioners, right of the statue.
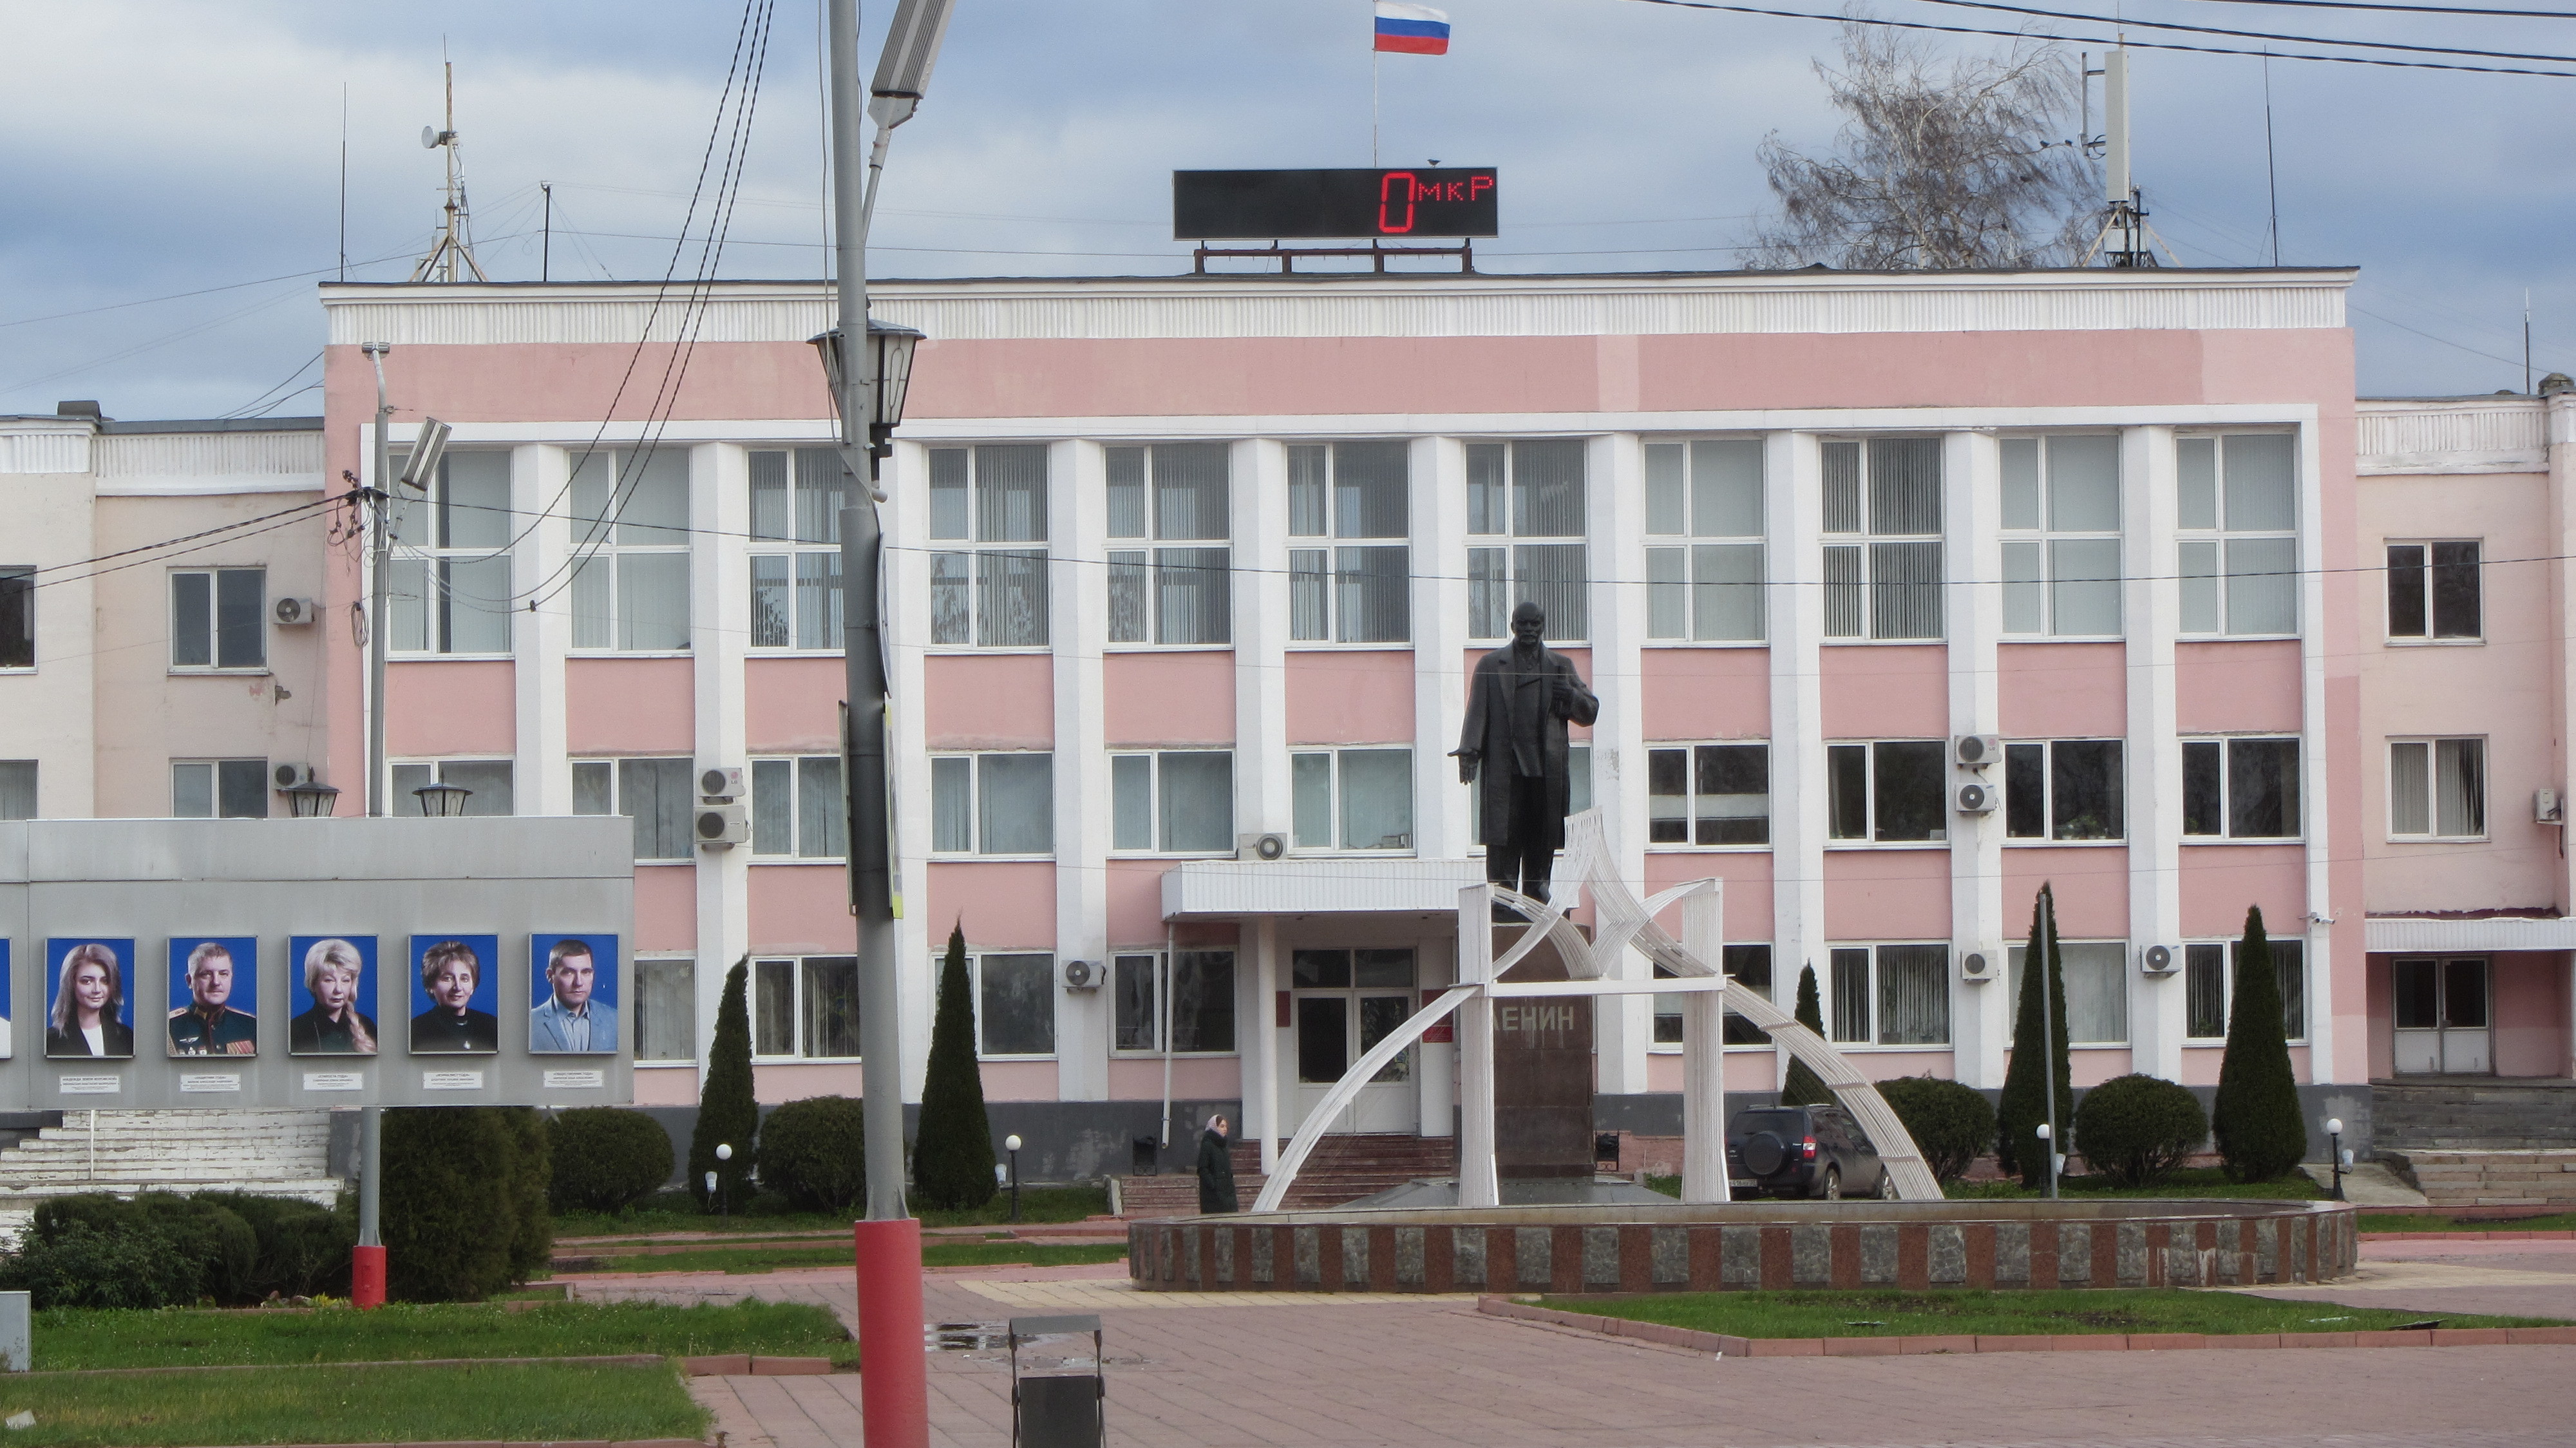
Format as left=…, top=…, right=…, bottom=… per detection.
left=1942, top=433, right=2012, bottom=1087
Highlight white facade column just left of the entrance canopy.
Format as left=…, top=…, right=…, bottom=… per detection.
left=1046, top=441, right=1113, bottom=1100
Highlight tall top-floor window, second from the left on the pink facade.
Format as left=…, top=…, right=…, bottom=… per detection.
left=572, top=443, right=688, bottom=654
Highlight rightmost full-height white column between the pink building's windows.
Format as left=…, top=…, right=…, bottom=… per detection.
left=2120, top=428, right=2190, bottom=1082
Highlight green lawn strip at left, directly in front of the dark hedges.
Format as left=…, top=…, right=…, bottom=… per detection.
left=32, top=1299, right=858, bottom=1360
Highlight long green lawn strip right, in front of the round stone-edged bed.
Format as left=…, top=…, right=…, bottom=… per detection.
left=1540, top=1288, right=2558, bottom=1337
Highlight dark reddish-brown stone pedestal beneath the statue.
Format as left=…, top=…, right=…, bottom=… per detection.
left=1492, top=925, right=1595, bottom=1183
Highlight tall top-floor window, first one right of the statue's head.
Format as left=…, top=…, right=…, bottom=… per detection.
left=1646, top=438, right=1765, bottom=644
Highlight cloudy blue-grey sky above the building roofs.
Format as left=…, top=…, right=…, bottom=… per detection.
left=0, top=0, right=2576, bottom=417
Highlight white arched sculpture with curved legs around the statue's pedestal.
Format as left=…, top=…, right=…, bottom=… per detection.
left=1252, top=809, right=1940, bottom=1211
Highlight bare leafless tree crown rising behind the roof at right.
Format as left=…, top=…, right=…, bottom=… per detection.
left=1747, top=23, right=2094, bottom=271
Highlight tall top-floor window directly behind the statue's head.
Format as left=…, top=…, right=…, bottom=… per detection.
left=1466, top=438, right=1592, bottom=642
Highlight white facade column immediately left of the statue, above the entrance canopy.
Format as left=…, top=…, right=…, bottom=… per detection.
left=1406, top=438, right=1476, bottom=861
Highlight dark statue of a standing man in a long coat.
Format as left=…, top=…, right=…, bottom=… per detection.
left=1458, top=603, right=1602, bottom=899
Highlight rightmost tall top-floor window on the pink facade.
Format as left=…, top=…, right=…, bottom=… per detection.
left=2174, top=433, right=2298, bottom=636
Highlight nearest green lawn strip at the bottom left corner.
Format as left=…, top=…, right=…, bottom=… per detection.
left=0, top=1360, right=708, bottom=1448
